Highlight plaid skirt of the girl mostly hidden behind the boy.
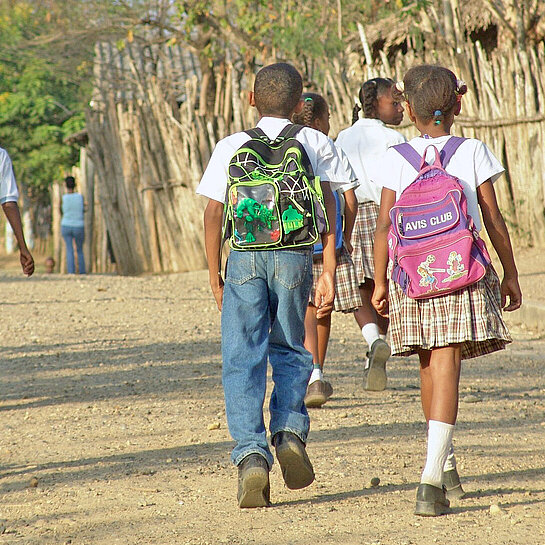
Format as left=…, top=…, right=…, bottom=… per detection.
left=309, top=244, right=362, bottom=312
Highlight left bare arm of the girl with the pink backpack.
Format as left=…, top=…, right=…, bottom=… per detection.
left=371, top=187, right=396, bottom=316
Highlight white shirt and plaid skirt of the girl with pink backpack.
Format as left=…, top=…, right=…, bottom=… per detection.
left=374, top=135, right=511, bottom=359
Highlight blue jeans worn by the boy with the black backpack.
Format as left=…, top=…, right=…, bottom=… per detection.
left=221, top=250, right=312, bottom=467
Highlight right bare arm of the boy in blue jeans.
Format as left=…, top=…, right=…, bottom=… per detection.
left=314, top=182, right=337, bottom=318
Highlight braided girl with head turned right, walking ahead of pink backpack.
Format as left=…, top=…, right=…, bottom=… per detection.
left=336, top=78, right=405, bottom=391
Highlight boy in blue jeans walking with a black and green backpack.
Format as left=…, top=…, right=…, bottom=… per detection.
left=197, top=63, right=346, bottom=507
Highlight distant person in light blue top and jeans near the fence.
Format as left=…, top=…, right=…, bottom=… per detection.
left=61, top=176, right=85, bottom=274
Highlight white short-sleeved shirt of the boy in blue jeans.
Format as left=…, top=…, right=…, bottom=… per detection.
left=197, top=117, right=356, bottom=203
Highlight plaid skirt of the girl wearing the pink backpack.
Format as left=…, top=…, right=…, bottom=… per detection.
left=389, top=265, right=512, bottom=359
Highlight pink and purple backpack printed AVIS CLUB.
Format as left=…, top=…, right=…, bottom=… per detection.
left=388, top=136, right=491, bottom=299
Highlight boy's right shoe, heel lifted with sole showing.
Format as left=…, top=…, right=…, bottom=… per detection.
left=273, top=431, right=314, bottom=490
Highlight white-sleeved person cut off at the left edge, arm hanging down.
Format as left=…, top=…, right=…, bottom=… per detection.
left=0, top=148, right=34, bottom=276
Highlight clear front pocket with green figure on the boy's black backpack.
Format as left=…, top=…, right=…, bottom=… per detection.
left=228, top=180, right=282, bottom=249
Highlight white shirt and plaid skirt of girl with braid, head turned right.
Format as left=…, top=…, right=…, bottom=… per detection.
left=335, top=118, right=406, bottom=284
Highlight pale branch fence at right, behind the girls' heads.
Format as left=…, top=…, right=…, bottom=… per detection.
left=325, top=35, right=545, bottom=248
